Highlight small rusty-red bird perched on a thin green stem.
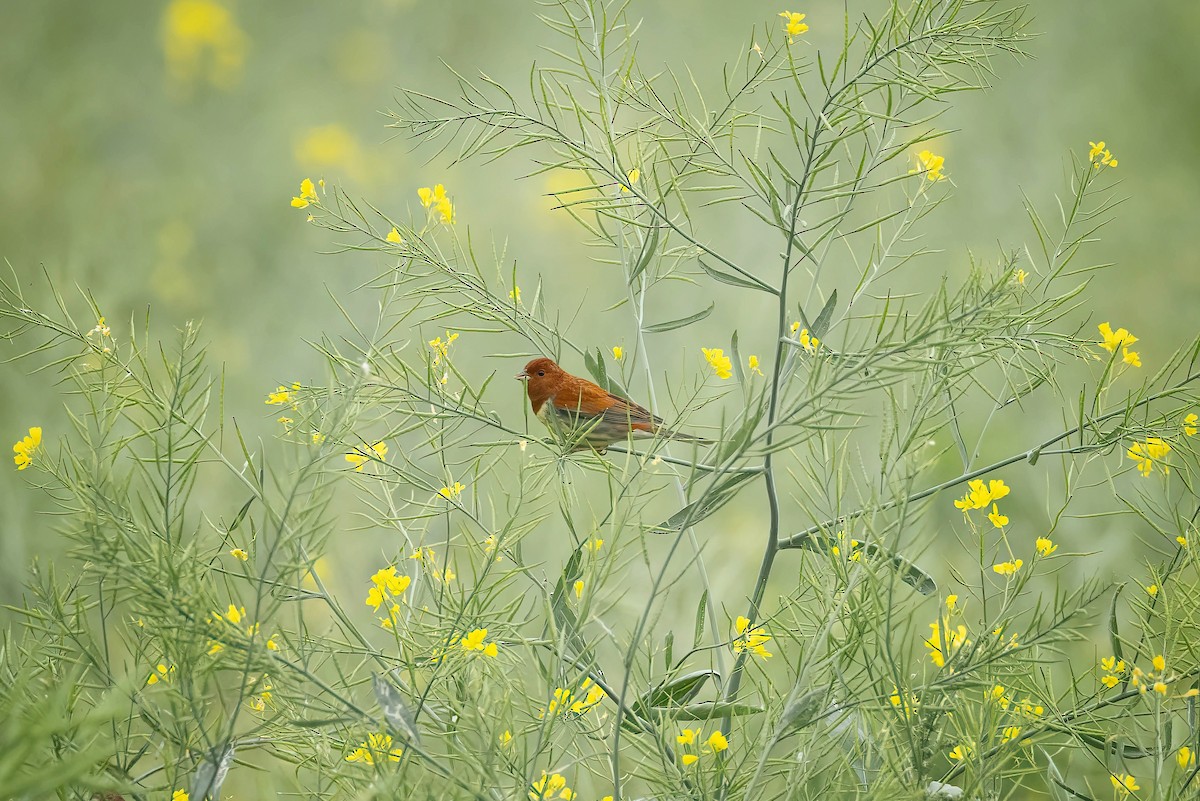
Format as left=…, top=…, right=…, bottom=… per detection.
left=516, top=356, right=712, bottom=453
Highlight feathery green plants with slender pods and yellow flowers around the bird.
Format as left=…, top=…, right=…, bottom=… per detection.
left=7, top=0, right=1200, bottom=800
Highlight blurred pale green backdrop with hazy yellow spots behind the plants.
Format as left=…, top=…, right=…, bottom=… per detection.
left=0, top=0, right=1200, bottom=600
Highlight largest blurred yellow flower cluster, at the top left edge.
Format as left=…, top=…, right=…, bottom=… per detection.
left=162, top=0, right=246, bottom=89
